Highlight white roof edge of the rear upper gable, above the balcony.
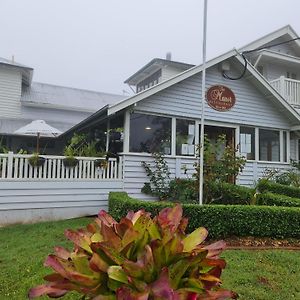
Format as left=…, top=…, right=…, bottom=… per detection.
left=238, top=25, right=300, bottom=53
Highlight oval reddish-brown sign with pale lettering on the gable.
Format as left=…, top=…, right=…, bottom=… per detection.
left=206, top=85, right=235, bottom=111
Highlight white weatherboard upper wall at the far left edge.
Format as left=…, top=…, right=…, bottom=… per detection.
left=0, top=68, right=22, bottom=118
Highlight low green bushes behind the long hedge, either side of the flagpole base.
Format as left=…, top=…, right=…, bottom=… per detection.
left=169, top=178, right=255, bottom=205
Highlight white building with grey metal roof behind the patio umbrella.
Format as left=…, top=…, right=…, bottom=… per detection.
left=0, top=58, right=124, bottom=153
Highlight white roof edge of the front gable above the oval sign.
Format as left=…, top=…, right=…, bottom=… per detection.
left=108, top=49, right=300, bottom=126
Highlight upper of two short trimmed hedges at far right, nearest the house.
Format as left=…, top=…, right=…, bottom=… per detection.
left=257, top=179, right=300, bottom=198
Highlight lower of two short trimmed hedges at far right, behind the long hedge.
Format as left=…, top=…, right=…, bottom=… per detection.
left=256, top=193, right=300, bottom=207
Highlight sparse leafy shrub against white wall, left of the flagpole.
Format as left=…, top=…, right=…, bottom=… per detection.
left=142, top=153, right=170, bottom=200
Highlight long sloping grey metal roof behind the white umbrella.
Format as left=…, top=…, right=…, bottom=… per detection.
left=21, top=82, right=126, bottom=112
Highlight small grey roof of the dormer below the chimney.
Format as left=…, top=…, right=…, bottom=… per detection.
left=124, top=58, right=195, bottom=85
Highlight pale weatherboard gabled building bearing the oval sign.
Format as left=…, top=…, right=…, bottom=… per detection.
left=62, top=26, right=300, bottom=198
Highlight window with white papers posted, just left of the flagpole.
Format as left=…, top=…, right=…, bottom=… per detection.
left=176, top=119, right=195, bottom=155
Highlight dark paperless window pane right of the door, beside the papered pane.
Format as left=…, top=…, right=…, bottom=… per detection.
left=259, top=129, right=280, bottom=161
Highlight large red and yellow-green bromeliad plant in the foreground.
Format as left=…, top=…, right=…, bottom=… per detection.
left=29, top=205, right=237, bottom=300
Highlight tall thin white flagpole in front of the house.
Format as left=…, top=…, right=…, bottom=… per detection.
left=199, top=0, right=207, bottom=205
